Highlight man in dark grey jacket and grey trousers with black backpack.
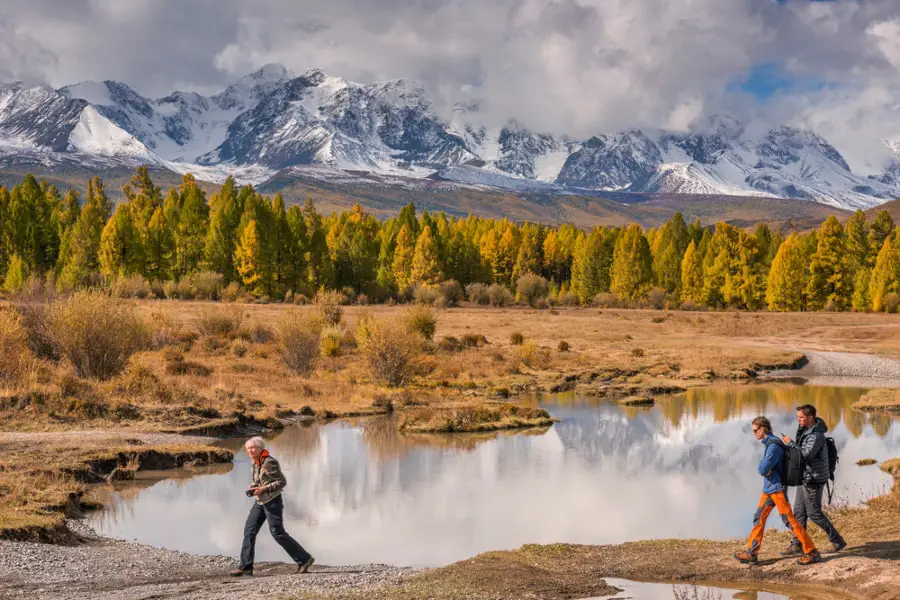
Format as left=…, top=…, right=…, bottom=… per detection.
left=782, top=404, right=847, bottom=556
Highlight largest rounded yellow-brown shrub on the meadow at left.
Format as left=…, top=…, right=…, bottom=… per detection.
left=49, top=292, right=150, bottom=379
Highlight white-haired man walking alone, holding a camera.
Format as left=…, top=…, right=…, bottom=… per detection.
left=231, top=437, right=314, bottom=577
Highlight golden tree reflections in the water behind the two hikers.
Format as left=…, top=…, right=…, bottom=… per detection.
left=661, top=385, right=891, bottom=437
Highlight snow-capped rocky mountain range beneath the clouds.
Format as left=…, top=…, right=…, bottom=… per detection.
left=0, top=65, right=900, bottom=208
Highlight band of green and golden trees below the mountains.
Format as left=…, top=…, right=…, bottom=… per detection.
left=0, top=167, right=900, bottom=311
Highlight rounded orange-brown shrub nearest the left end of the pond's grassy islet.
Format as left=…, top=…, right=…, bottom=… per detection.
left=357, top=321, right=421, bottom=387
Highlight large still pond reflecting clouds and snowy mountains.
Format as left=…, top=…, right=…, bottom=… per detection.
left=91, top=385, right=900, bottom=566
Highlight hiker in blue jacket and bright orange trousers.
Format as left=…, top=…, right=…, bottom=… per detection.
left=734, top=417, right=822, bottom=565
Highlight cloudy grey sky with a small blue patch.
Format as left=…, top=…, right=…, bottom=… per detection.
left=0, top=0, right=900, bottom=171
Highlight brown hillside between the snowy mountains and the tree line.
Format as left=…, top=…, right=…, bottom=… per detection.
left=0, top=164, right=848, bottom=230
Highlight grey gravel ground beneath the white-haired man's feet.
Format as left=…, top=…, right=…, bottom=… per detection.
left=0, top=522, right=417, bottom=600
